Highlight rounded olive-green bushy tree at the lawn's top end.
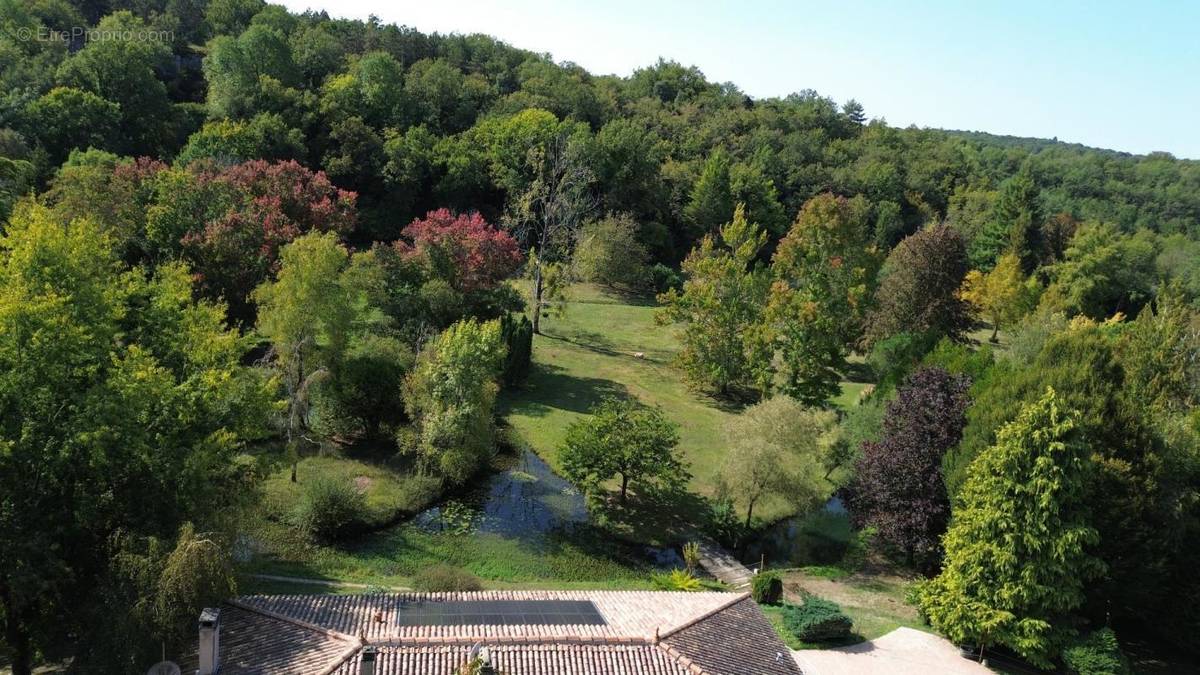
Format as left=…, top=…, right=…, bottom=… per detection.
left=574, top=214, right=649, bottom=289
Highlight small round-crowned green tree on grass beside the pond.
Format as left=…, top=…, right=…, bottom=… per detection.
left=559, top=399, right=688, bottom=503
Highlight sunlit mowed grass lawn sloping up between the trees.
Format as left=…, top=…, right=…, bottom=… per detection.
left=502, top=285, right=790, bottom=519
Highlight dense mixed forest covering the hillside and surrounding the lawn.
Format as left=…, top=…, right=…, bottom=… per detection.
left=0, top=0, right=1200, bottom=675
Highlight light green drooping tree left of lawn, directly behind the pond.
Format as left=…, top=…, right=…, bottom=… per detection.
left=404, top=319, right=504, bottom=483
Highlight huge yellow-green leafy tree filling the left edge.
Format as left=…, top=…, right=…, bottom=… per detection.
left=0, top=205, right=268, bottom=675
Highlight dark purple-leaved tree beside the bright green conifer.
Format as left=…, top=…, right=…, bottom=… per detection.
left=850, top=368, right=971, bottom=572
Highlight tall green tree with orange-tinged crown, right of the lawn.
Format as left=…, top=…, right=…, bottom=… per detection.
left=766, top=195, right=878, bottom=405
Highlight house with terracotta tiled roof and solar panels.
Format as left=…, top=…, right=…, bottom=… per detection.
left=184, top=591, right=800, bottom=675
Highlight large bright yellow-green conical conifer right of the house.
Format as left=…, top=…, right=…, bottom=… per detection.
left=918, top=389, right=1104, bottom=667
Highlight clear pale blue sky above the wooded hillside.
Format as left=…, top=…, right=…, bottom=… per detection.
left=274, top=0, right=1200, bottom=159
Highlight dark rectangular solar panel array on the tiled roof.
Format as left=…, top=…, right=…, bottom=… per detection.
left=396, top=601, right=607, bottom=626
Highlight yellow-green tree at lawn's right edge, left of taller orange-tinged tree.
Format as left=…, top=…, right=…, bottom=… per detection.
left=659, top=201, right=769, bottom=395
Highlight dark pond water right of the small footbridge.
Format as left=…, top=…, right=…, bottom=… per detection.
left=739, top=496, right=851, bottom=567
